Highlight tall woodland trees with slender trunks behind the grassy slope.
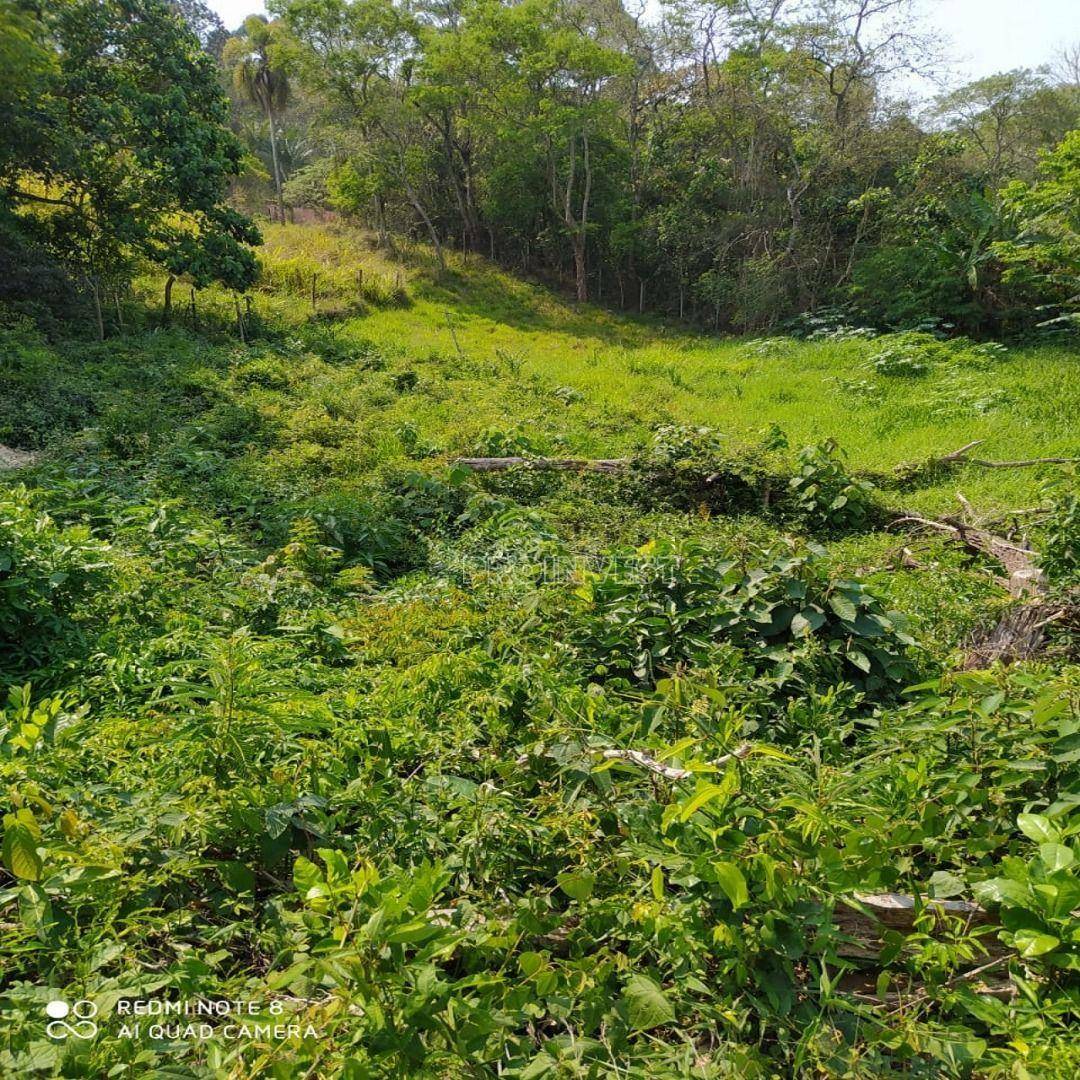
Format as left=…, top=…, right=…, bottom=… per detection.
left=261, top=0, right=1080, bottom=330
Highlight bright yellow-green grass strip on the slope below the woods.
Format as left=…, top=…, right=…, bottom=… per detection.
left=162, top=219, right=1080, bottom=511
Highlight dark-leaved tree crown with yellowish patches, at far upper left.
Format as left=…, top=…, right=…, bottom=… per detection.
left=0, top=0, right=259, bottom=324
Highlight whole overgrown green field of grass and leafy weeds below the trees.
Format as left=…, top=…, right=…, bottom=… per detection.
left=0, top=226, right=1080, bottom=1080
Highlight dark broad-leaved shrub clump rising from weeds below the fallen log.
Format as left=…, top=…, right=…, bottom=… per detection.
left=572, top=541, right=914, bottom=690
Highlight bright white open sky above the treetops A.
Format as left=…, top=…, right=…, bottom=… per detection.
left=207, top=0, right=1080, bottom=81
